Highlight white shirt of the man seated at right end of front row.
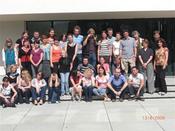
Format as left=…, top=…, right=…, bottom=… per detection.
left=129, top=73, right=144, bottom=88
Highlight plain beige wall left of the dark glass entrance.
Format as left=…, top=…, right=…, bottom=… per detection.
left=0, top=21, right=25, bottom=65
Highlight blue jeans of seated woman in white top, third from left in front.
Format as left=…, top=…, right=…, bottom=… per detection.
left=31, top=86, right=46, bottom=100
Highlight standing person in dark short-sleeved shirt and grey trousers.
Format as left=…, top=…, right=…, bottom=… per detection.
left=138, top=39, right=155, bottom=94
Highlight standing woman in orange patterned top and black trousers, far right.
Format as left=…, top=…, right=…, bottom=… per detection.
left=154, top=38, right=169, bottom=95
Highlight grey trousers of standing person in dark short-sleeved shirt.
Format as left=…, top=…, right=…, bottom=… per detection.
left=146, top=63, right=155, bottom=93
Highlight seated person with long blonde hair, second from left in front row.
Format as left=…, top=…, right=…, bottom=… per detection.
left=17, top=70, right=32, bottom=104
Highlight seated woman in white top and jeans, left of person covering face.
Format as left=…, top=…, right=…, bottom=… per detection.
left=31, top=72, right=47, bottom=105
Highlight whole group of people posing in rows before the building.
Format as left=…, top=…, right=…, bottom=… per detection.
left=0, top=26, right=169, bottom=107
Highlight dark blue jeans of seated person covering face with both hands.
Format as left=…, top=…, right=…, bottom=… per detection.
left=48, top=87, right=61, bottom=103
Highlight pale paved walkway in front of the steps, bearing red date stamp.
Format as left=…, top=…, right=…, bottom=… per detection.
left=0, top=98, right=175, bottom=131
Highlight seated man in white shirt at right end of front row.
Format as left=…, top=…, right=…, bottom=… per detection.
left=128, top=66, right=144, bottom=100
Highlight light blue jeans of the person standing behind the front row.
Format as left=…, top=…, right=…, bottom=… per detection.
left=60, top=72, right=70, bottom=95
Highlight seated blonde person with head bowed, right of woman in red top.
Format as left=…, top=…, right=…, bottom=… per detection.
left=82, top=69, right=95, bottom=102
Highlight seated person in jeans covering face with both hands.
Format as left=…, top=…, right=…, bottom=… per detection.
left=48, top=73, right=61, bottom=103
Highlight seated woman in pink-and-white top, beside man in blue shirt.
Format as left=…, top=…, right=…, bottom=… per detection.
left=93, top=66, right=110, bottom=101
